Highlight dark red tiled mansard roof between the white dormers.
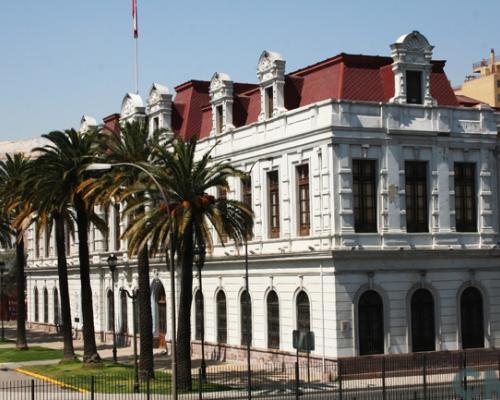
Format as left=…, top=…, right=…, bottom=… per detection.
left=172, top=53, right=461, bottom=138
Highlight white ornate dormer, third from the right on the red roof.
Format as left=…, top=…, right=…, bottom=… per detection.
left=210, top=72, right=234, bottom=134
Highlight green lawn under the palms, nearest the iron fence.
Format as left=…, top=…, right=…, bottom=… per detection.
left=24, top=361, right=231, bottom=394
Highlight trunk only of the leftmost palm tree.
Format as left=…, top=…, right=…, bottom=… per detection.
left=16, top=231, right=28, bottom=350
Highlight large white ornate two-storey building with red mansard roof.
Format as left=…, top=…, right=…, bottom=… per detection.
left=21, top=32, right=500, bottom=359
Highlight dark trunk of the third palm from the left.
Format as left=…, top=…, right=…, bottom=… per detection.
left=75, top=195, right=101, bottom=363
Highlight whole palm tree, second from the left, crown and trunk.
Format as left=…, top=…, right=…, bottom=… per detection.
left=14, top=156, right=80, bottom=360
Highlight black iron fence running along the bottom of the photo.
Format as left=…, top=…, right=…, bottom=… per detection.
left=0, top=350, right=500, bottom=400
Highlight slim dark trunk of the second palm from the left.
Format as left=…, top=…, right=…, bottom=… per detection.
left=55, top=214, right=76, bottom=360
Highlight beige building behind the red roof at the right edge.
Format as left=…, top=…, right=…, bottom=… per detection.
left=455, top=49, right=500, bottom=108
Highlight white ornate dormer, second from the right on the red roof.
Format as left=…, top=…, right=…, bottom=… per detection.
left=257, top=51, right=286, bottom=121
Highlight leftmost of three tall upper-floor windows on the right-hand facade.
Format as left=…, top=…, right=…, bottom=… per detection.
left=352, top=160, right=377, bottom=232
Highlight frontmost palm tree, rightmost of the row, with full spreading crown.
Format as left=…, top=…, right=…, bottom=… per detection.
left=125, top=138, right=253, bottom=389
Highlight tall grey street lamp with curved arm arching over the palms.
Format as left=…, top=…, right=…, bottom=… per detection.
left=87, top=162, right=177, bottom=400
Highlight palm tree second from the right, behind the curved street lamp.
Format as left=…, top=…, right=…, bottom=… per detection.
left=82, top=119, right=161, bottom=379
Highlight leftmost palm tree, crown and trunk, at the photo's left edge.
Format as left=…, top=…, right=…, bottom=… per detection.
left=0, top=153, right=30, bottom=350
